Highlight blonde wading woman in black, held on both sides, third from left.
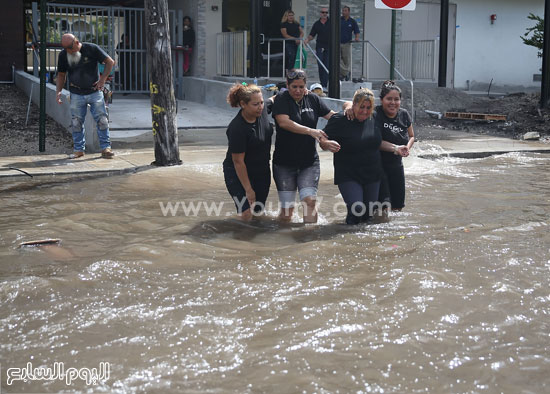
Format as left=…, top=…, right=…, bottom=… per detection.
left=320, top=88, right=407, bottom=224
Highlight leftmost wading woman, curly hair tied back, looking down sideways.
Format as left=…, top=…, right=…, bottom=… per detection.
left=223, top=83, right=273, bottom=221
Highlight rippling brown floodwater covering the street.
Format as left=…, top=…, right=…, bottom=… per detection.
left=0, top=144, right=550, bottom=393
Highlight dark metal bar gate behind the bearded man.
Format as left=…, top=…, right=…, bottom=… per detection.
left=26, top=3, right=177, bottom=93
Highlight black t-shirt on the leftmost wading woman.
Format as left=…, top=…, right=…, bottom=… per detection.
left=223, top=106, right=273, bottom=173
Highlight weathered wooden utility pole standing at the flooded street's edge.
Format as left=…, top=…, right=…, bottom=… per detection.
left=145, top=0, right=181, bottom=166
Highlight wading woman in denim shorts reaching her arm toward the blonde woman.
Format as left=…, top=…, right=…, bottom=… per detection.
left=272, top=69, right=335, bottom=223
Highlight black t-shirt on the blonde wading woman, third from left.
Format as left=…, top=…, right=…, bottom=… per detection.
left=325, top=112, right=382, bottom=185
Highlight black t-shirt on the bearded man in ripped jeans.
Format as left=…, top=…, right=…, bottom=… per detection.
left=57, top=42, right=109, bottom=94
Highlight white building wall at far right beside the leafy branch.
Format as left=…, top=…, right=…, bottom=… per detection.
left=455, top=0, right=544, bottom=88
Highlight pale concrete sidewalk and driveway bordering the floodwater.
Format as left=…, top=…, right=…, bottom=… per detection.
left=0, top=95, right=550, bottom=178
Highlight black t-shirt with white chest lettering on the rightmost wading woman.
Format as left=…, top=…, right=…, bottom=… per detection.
left=374, top=105, right=412, bottom=167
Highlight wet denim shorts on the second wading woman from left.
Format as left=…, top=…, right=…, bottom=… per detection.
left=273, top=160, right=321, bottom=208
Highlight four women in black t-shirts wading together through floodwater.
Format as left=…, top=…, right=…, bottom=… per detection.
left=223, top=69, right=414, bottom=224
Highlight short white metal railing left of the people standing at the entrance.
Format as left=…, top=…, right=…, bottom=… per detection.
left=216, top=30, right=248, bottom=77
